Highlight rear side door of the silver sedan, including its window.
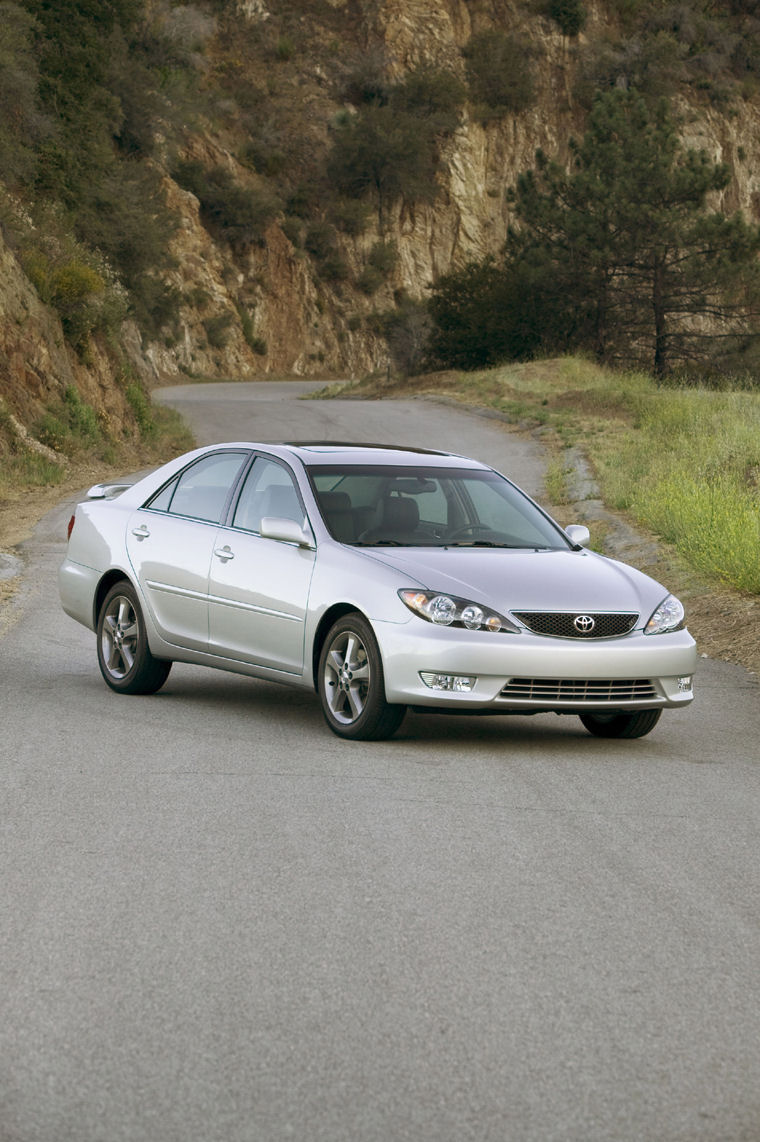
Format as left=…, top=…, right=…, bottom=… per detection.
left=127, top=451, right=249, bottom=651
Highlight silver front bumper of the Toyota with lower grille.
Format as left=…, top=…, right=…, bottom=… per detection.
left=375, top=620, right=697, bottom=714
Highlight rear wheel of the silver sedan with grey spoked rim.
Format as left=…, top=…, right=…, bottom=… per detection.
left=97, top=579, right=171, bottom=694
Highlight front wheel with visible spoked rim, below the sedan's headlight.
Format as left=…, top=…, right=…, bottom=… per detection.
left=317, top=613, right=407, bottom=741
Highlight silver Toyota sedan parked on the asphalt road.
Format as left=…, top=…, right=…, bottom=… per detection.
left=59, top=443, right=696, bottom=740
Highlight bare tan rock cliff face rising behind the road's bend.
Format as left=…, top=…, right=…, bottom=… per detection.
left=144, top=0, right=582, bottom=379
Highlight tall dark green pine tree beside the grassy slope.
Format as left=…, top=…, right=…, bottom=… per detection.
left=505, top=90, right=760, bottom=376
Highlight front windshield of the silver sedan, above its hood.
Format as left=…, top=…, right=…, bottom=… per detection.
left=309, top=465, right=569, bottom=549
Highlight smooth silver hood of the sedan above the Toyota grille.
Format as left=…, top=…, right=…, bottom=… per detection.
left=361, top=547, right=667, bottom=622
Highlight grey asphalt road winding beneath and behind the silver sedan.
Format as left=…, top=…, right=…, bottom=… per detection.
left=0, top=385, right=760, bottom=1142
